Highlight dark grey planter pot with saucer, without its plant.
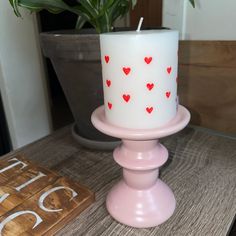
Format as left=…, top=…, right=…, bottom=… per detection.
left=40, top=30, right=118, bottom=150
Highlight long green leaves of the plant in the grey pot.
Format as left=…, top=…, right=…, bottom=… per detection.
left=9, top=0, right=142, bottom=33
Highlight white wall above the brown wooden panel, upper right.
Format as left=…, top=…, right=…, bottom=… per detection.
left=163, top=0, right=236, bottom=40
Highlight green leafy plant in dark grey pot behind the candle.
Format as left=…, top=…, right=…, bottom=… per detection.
left=9, top=0, right=194, bottom=149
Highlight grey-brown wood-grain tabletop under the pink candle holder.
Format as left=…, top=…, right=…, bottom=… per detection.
left=2, top=127, right=236, bottom=236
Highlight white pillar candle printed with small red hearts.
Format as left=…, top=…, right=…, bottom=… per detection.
left=100, top=30, right=178, bottom=129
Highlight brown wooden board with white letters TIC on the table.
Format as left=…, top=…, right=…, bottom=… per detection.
left=0, top=155, right=94, bottom=236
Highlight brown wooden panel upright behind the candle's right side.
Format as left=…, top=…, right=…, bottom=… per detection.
left=178, top=41, right=236, bottom=134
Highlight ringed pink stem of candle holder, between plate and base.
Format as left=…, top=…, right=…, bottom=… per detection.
left=114, top=140, right=168, bottom=189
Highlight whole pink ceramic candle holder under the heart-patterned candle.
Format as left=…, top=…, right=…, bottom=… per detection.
left=92, top=105, right=190, bottom=228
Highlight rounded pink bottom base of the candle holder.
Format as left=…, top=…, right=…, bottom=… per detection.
left=106, top=179, right=175, bottom=228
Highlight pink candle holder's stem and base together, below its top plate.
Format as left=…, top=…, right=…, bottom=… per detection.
left=106, top=140, right=175, bottom=228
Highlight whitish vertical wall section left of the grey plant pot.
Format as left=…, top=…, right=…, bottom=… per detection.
left=0, top=0, right=51, bottom=149
